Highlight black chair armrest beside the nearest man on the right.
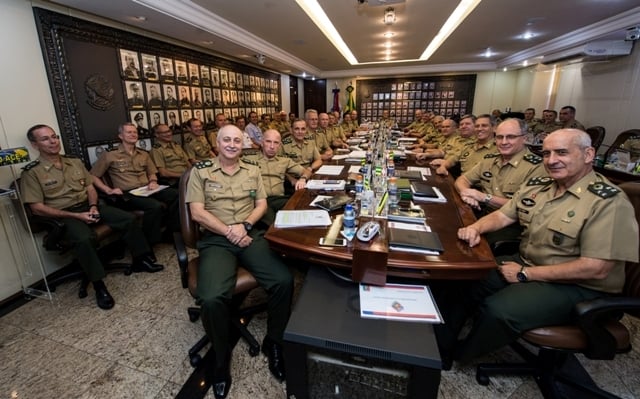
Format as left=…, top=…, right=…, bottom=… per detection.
left=576, top=296, right=640, bottom=360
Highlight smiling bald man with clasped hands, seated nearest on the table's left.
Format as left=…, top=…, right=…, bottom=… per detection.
left=186, top=125, right=293, bottom=398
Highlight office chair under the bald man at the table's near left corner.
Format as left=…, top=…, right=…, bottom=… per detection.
left=174, top=169, right=267, bottom=367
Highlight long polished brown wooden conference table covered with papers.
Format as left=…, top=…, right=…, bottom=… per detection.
left=265, top=160, right=496, bottom=280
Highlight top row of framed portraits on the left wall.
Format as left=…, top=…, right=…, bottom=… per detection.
left=119, top=49, right=278, bottom=92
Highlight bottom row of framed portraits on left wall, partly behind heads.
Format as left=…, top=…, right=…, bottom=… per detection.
left=129, top=107, right=279, bottom=136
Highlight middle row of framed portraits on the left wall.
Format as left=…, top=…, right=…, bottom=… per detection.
left=123, top=80, right=280, bottom=109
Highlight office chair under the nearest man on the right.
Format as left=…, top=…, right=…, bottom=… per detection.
left=476, top=182, right=640, bottom=398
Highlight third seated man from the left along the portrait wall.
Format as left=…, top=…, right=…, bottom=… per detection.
left=149, top=123, right=191, bottom=188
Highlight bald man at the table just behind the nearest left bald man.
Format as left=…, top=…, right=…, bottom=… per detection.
left=242, top=129, right=313, bottom=226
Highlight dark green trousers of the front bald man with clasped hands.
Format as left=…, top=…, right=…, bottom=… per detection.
left=197, top=229, right=293, bottom=364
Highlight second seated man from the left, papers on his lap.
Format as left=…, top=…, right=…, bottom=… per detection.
left=91, top=123, right=180, bottom=245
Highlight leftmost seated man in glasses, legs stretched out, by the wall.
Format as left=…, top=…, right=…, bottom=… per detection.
left=20, top=125, right=164, bottom=309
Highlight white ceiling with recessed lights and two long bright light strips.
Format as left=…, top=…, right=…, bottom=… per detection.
left=43, top=0, right=640, bottom=78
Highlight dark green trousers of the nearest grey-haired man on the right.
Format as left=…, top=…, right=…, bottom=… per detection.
left=436, top=255, right=608, bottom=362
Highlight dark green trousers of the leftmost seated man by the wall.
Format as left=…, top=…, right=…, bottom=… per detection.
left=61, top=203, right=151, bottom=281
